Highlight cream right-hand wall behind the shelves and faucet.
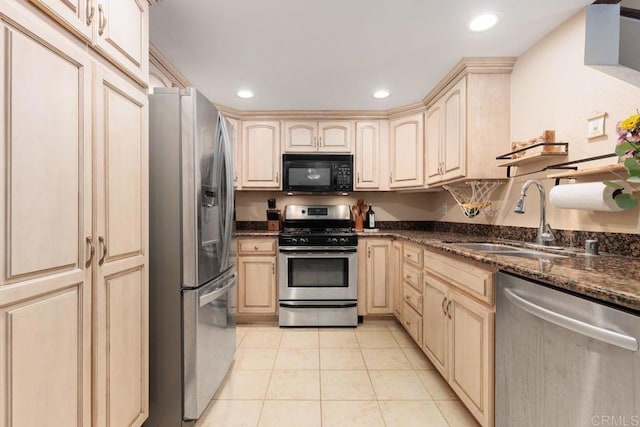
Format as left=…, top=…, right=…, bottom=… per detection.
left=432, top=11, right=640, bottom=234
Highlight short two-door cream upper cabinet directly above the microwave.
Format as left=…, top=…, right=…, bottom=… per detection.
left=283, top=120, right=353, bottom=153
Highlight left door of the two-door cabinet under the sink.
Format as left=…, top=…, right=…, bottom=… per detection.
left=423, top=273, right=449, bottom=378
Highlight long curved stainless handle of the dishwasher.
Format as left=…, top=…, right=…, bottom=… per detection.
left=504, top=289, right=638, bottom=351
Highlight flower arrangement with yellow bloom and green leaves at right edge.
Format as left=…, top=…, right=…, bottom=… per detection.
left=604, top=112, right=640, bottom=209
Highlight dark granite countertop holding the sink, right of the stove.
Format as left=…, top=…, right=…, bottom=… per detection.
left=359, top=230, right=640, bottom=312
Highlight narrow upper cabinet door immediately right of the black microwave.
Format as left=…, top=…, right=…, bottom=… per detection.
left=355, top=122, right=380, bottom=190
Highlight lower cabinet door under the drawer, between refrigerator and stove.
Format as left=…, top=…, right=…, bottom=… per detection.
left=238, top=256, right=278, bottom=314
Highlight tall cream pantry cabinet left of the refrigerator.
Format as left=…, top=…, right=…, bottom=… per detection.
left=0, top=0, right=148, bottom=427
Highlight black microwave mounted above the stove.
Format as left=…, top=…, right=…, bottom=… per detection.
left=282, top=154, right=353, bottom=193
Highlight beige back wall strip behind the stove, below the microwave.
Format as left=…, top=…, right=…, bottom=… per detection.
left=236, top=191, right=437, bottom=221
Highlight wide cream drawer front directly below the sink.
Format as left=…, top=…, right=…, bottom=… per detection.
left=424, top=250, right=496, bottom=305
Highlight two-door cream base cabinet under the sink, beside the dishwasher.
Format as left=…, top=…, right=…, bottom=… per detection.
left=422, top=250, right=495, bottom=427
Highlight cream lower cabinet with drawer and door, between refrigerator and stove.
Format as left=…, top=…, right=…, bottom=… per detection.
left=237, top=238, right=278, bottom=314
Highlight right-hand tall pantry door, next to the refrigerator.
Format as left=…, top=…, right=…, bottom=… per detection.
left=94, top=67, right=149, bottom=426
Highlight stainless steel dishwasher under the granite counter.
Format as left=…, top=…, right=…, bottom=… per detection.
left=495, top=272, right=640, bottom=427
